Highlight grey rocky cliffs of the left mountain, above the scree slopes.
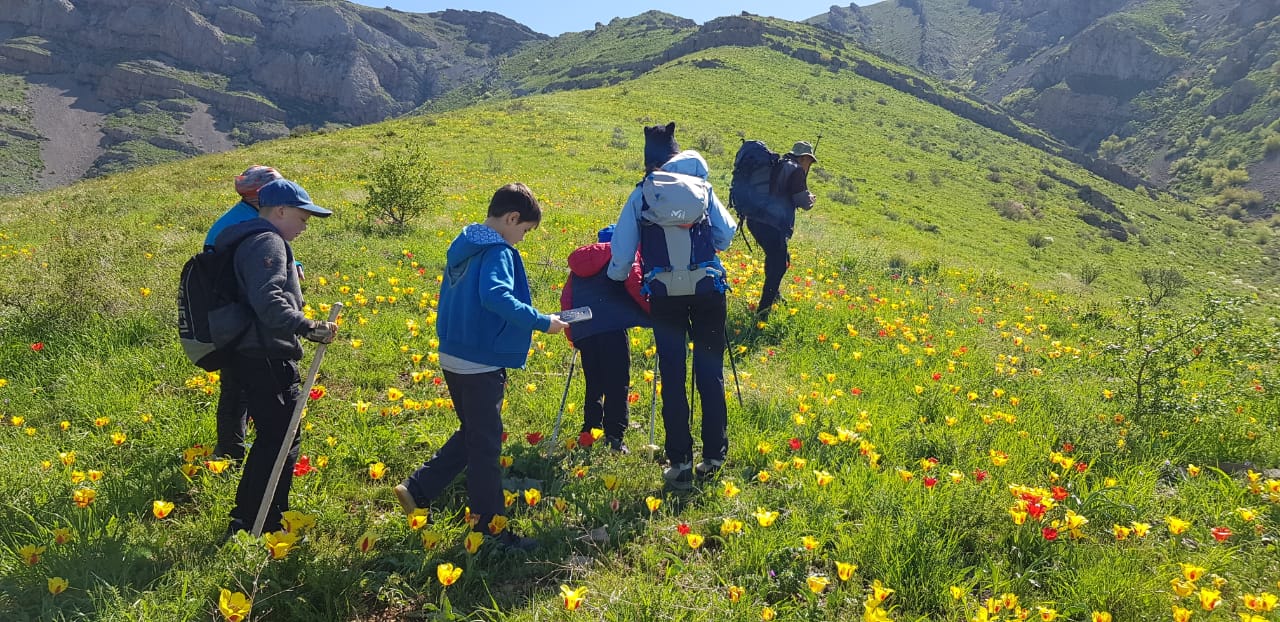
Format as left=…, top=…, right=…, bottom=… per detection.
left=0, top=0, right=547, bottom=191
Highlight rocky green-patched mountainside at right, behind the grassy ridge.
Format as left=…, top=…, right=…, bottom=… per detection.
left=808, top=0, right=1280, bottom=218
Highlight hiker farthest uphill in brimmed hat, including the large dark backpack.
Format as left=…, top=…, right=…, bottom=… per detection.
left=728, top=134, right=822, bottom=321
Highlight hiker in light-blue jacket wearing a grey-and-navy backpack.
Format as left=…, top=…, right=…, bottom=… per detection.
left=608, top=123, right=737, bottom=490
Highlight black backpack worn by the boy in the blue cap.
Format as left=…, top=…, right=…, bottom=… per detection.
left=178, top=244, right=248, bottom=371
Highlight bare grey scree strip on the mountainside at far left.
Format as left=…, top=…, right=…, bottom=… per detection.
left=27, top=77, right=110, bottom=189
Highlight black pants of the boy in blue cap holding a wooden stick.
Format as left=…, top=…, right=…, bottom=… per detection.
left=223, top=357, right=302, bottom=532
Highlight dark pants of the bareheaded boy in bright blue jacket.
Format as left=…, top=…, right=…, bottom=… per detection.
left=404, top=370, right=507, bottom=531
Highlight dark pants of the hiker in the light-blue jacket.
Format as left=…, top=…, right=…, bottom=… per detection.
left=649, top=293, right=728, bottom=465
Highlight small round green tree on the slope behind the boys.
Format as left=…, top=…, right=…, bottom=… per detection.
left=365, top=145, right=440, bottom=228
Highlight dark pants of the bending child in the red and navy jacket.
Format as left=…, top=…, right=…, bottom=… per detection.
left=573, top=330, right=631, bottom=439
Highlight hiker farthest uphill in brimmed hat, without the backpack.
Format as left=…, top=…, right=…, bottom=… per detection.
left=746, top=141, right=818, bottom=321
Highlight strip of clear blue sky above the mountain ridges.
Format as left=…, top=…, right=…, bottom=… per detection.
left=357, top=0, right=873, bottom=35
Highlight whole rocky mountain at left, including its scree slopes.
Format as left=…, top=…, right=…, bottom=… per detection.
left=0, top=0, right=547, bottom=193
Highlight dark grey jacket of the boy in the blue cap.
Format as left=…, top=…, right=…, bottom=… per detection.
left=214, top=218, right=311, bottom=361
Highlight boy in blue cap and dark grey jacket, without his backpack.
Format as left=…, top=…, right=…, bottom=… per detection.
left=211, top=179, right=338, bottom=535
